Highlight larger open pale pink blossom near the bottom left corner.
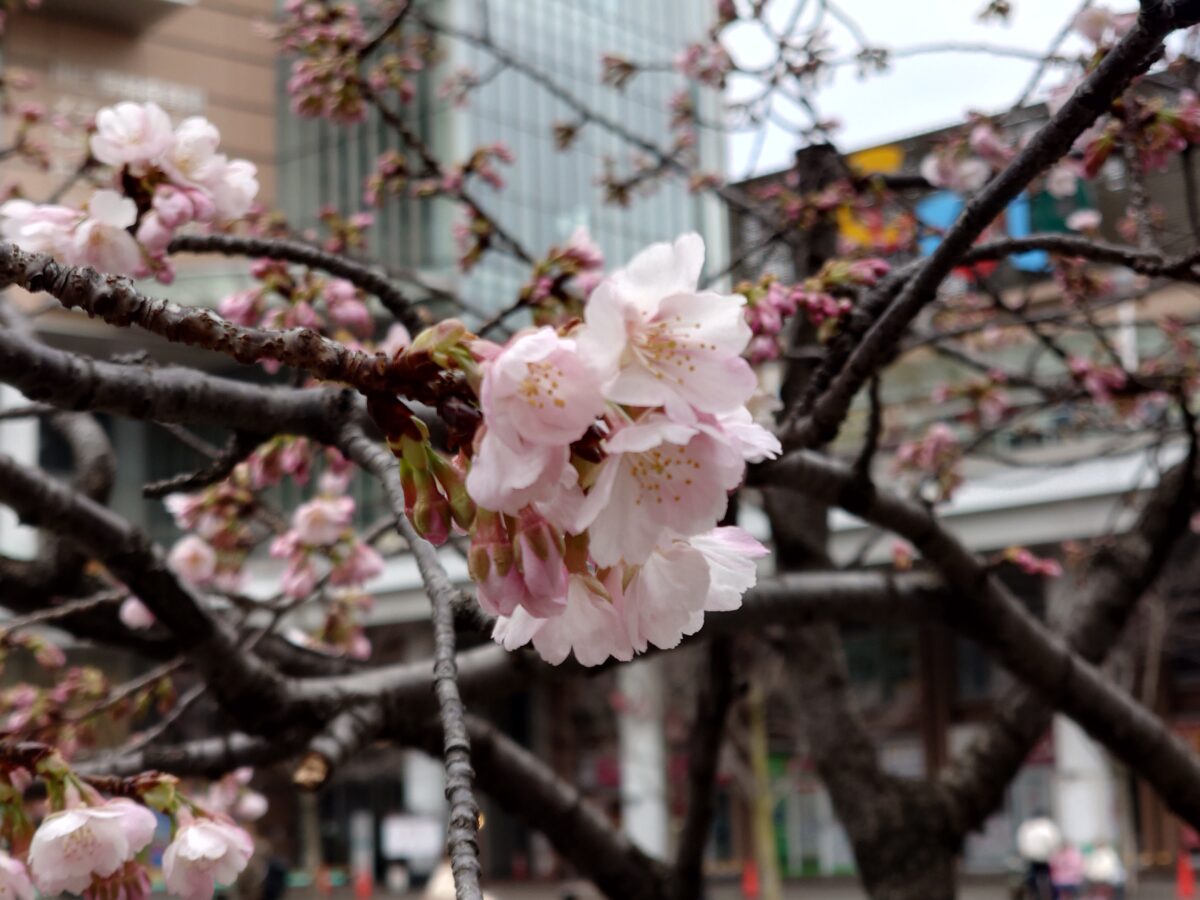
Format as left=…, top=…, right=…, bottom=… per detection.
left=29, top=799, right=156, bottom=896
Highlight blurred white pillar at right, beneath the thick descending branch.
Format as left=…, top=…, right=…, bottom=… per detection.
left=1054, top=715, right=1118, bottom=846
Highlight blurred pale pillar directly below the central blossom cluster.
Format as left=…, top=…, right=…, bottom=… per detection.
left=617, top=658, right=668, bottom=859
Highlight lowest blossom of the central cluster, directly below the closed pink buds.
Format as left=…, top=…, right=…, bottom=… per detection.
left=492, top=571, right=634, bottom=666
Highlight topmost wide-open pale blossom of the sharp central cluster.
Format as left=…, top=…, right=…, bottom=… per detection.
left=578, top=234, right=757, bottom=418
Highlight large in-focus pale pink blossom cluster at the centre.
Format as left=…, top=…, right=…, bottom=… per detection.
left=446, top=234, right=780, bottom=665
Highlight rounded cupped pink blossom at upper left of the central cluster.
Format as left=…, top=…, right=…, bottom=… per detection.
left=480, top=328, right=605, bottom=446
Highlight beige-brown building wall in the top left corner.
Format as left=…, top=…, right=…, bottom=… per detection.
left=2, top=0, right=276, bottom=206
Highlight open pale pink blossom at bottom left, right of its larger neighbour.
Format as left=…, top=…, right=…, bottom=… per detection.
left=162, top=818, right=254, bottom=900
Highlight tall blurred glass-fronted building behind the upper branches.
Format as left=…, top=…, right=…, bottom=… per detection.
left=280, top=0, right=727, bottom=311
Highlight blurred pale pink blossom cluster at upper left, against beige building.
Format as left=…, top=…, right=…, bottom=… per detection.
left=0, top=103, right=258, bottom=282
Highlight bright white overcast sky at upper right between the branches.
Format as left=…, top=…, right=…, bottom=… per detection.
left=726, top=0, right=1104, bottom=178
